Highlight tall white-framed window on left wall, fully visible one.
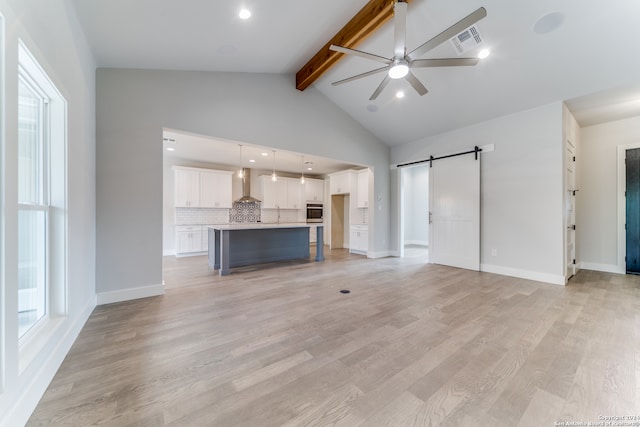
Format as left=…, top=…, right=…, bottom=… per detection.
left=18, top=43, right=67, bottom=343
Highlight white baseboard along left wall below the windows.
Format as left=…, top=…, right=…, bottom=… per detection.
left=0, top=297, right=96, bottom=426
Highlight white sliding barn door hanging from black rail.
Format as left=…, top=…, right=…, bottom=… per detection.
left=429, top=155, right=480, bottom=271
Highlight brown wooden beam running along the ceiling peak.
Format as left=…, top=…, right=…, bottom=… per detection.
left=296, top=0, right=409, bottom=90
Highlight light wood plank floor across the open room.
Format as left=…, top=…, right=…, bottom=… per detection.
left=29, top=250, right=640, bottom=427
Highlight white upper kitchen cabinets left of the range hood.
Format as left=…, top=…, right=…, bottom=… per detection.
left=174, top=166, right=233, bottom=208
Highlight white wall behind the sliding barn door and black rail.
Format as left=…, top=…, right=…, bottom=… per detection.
left=391, top=102, right=564, bottom=284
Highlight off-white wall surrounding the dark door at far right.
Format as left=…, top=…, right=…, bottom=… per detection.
left=576, top=117, right=640, bottom=273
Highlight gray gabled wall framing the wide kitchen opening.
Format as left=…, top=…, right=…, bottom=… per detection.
left=96, top=69, right=389, bottom=299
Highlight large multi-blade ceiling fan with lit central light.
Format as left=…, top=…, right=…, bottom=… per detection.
left=329, top=0, right=487, bottom=101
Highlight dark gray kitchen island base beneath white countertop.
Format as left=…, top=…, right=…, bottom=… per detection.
left=208, top=224, right=324, bottom=276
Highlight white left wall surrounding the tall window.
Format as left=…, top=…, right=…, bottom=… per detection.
left=0, top=0, right=96, bottom=426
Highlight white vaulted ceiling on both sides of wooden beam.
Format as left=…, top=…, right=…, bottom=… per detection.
left=73, top=0, right=640, bottom=146
